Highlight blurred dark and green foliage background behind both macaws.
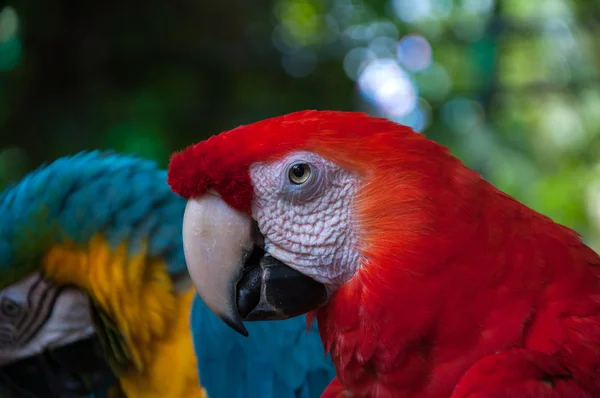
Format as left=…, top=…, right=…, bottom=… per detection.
left=0, top=0, right=600, bottom=250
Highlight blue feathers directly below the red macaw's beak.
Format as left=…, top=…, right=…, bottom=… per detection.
left=191, top=295, right=335, bottom=398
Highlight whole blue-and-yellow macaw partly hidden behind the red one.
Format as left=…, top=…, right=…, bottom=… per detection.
left=0, top=151, right=335, bottom=398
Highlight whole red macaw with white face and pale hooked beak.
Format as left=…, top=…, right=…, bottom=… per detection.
left=168, top=111, right=600, bottom=398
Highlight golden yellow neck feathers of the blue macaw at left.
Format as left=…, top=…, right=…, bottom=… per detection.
left=42, top=236, right=206, bottom=398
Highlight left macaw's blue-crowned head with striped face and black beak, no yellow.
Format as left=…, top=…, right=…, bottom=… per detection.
left=0, top=151, right=187, bottom=398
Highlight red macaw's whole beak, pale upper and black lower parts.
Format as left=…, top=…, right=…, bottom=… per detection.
left=183, top=193, right=328, bottom=336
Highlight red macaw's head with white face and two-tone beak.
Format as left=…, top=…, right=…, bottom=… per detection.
left=168, top=111, right=468, bottom=335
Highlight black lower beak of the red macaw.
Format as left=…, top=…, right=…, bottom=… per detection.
left=236, top=246, right=329, bottom=321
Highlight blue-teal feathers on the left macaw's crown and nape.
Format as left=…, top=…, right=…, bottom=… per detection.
left=0, top=151, right=186, bottom=288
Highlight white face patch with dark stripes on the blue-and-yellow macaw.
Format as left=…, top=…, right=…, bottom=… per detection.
left=0, top=272, right=94, bottom=366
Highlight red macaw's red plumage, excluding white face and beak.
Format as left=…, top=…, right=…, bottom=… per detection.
left=169, top=111, right=600, bottom=398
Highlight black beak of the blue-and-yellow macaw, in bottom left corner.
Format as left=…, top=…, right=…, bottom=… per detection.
left=0, top=337, right=117, bottom=398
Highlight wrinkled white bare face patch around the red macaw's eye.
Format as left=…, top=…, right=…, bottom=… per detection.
left=250, top=152, right=359, bottom=289
